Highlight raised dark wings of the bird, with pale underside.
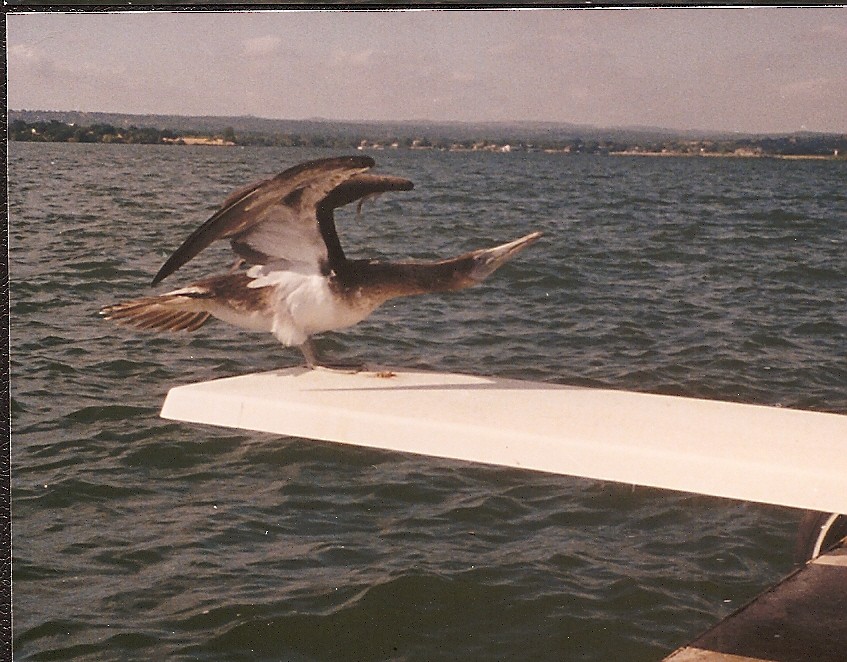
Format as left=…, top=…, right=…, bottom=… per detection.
left=153, top=156, right=412, bottom=285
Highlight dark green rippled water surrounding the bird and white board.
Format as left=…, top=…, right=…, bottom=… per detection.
left=9, top=143, right=847, bottom=660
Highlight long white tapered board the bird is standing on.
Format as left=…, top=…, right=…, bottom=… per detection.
left=161, top=368, right=847, bottom=514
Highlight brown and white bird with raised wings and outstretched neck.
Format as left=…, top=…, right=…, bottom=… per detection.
left=100, top=155, right=541, bottom=369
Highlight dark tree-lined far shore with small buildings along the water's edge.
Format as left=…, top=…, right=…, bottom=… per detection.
left=9, top=119, right=847, bottom=158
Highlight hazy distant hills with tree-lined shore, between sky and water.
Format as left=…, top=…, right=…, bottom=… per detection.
left=8, top=110, right=847, bottom=159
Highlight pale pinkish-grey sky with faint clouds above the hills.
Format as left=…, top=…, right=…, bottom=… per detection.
left=7, top=7, right=847, bottom=133
